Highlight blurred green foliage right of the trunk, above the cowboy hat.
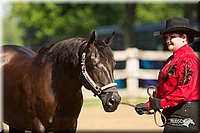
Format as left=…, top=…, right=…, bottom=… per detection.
left=136, top=3, right=197, bottom=23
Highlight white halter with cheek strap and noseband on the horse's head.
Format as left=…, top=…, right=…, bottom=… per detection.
left=81, top=52, right=117, bottom=96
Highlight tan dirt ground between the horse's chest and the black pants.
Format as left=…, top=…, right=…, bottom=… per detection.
left=77, top=105, right=163, bottom=133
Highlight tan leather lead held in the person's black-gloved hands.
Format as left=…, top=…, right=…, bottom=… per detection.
left=120, top=86, right=167, bottom=127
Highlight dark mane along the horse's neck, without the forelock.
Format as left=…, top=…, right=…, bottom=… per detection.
left=38, top=38, right=85, bottom=69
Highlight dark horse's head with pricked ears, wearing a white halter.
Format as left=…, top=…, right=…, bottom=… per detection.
left=81, top=31, right=121, bottom=112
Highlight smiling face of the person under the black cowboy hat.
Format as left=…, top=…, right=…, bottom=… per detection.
left=165, top=33, right=186, bottom=52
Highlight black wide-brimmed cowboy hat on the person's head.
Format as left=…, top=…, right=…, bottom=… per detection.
left=153, top=18, right=200, bottom=37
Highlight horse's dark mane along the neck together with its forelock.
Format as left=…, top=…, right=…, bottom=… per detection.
left=37, top=38, right=113, bottom=69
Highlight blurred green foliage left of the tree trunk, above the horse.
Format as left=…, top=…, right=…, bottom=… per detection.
left=7, top=3, right=122, bottom=49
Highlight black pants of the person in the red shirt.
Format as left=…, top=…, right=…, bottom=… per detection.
left=163, top=101, right=200, bottom=133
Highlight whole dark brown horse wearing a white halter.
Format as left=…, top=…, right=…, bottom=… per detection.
left=1, top=31, right=121, bottom=133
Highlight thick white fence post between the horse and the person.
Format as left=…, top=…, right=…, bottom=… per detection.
left=126, top=48, right=140, bottom=96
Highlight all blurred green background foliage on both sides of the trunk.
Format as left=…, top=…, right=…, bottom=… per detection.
left=5, top=2, right=195, bottom=49
